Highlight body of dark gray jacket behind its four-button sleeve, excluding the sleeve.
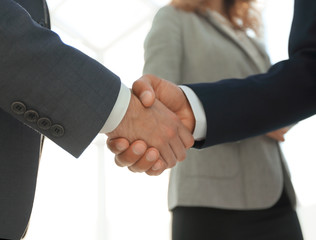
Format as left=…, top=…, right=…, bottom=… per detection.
left=0, top=0, right=49, bottom=240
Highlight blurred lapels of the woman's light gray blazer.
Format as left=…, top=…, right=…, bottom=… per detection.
left=199, top=11, right=270, bottom=72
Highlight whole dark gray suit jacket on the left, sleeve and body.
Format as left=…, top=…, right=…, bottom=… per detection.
left=0, top=0, right=121, bottom=239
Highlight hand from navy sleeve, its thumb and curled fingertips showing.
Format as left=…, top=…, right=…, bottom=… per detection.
left=107, top=75, right=195, bottom=175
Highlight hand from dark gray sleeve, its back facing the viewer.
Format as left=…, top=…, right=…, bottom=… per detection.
left=107, top=94, right=194, bottom=167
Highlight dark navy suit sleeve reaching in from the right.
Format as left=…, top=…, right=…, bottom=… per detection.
left=188, top=0, right=316, bottom=148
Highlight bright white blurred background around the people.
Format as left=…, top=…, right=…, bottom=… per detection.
left=26, top=0, right=316, bottom=240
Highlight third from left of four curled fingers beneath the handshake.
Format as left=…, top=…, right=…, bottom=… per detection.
left=128, top=148, right=159, bottom=172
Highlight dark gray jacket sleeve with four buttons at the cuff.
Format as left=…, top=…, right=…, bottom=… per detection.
left=0, top=0, right=121, bottom=157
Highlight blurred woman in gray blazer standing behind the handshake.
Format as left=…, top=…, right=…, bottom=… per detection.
left=144, top=0, right=303, bottom=240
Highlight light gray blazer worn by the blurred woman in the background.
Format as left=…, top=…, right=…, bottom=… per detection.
left=144, top=6, right=295, bottom=209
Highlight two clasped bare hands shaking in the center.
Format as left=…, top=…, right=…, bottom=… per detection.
left=107, top=75, right=195, bottom=175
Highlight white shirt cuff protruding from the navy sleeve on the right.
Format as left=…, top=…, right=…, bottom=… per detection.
left=179, top=85, right=207, bottom=141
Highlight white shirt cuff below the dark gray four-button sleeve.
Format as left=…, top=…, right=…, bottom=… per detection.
left=100, top=83, right=131, bottom=133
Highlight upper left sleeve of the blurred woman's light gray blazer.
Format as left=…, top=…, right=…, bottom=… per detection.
left=143, top=6, right=183, bottom=84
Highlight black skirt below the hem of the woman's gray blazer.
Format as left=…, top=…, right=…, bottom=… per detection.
left=172, top=191, right=303, bottom=240
